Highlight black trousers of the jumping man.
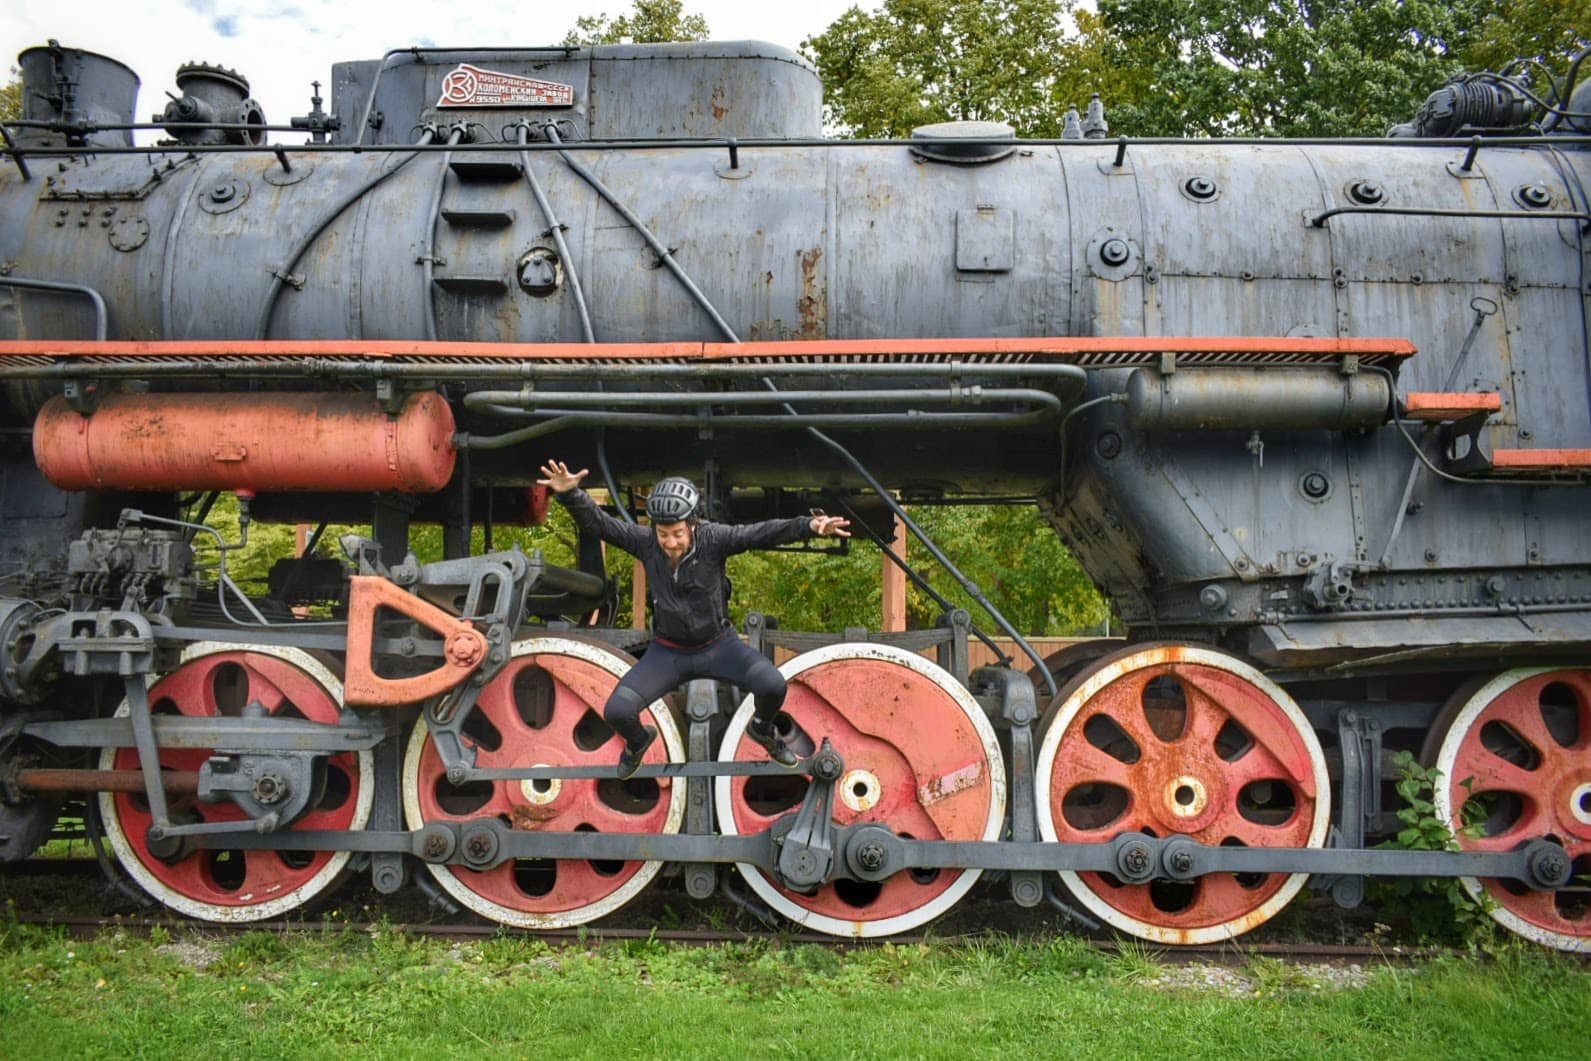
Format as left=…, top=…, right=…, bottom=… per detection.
left=603, top=630, right=784, bottom=746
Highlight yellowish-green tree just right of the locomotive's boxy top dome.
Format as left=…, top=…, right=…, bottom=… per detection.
left=802, top=0, right=1091, bottom=137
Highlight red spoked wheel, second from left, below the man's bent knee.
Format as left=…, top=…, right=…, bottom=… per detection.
left=403, top=638, right=686, bottom=929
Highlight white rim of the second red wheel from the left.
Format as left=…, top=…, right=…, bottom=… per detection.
left=403, top=638, right=686, bottom=931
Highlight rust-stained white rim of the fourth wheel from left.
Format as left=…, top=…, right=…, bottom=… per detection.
left=1034, top=646, right=1332, bottom=945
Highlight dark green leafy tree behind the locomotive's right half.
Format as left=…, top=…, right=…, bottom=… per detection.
left=1099, top=0, right=1527, bottom=137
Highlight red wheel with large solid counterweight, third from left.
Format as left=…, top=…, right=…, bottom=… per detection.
left=714, top=644, right=1006, bottom=937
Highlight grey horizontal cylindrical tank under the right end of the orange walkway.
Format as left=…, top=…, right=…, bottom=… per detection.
left=1126, top=367, right=1392, bottom=431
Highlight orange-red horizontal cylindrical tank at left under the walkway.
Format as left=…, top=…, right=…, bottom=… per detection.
left=33, top=391, right=455, bottom=493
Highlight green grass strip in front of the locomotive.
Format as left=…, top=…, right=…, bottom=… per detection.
left=0, top=921, right=1591, bottom=1058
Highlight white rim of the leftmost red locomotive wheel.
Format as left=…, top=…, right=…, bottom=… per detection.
left=99, top=641, right=375, bottom=924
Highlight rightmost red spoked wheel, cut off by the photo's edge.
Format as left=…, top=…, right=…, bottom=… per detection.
left=1433, top=668, right=1591, bottom=953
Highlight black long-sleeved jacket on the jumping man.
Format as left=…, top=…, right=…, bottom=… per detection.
left=554, top=488, right=811, bottom=646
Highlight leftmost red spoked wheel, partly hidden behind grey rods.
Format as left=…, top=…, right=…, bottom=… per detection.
left=99, top=641, right=375, bottom=923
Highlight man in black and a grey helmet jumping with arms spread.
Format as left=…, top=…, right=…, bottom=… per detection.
left=538, top=460, right=851, bottom=778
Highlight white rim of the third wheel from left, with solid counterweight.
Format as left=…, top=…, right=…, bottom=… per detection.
left=714, top=643, right=1006, bottom=939
